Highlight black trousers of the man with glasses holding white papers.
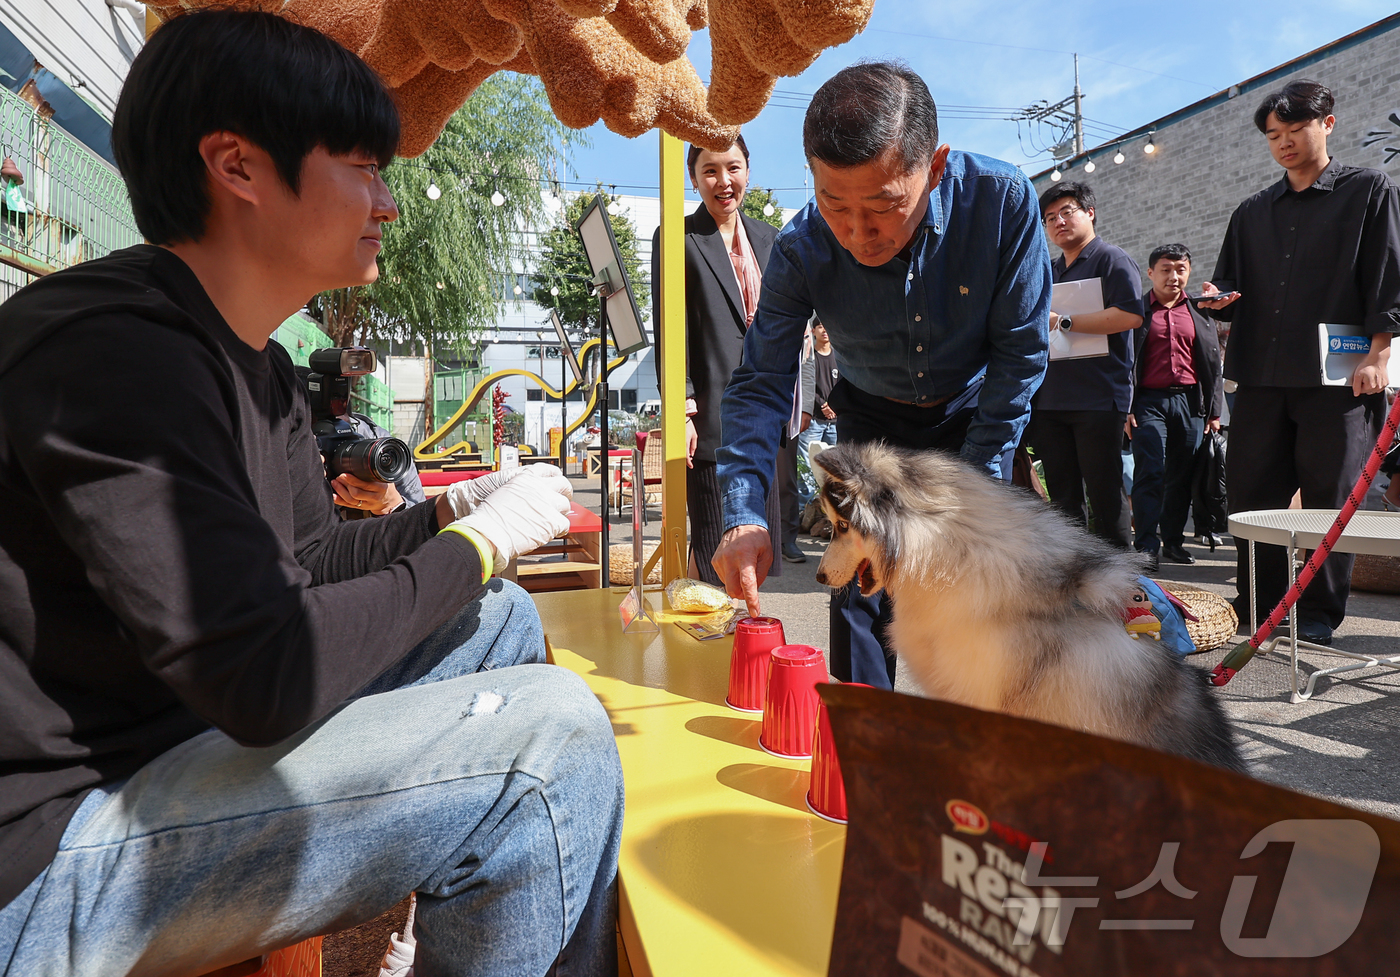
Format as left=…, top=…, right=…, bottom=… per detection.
left=1025, top=410, right=1133, bottom=550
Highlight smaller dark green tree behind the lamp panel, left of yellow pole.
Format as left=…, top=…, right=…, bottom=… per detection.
left=531, top=186, right=651, bottom=337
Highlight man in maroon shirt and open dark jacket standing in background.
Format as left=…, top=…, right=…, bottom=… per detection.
left=1127, top=244, right=1224, bottom=570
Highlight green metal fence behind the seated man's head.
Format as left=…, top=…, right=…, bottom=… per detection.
left=0, top=88, right=141, bottom=301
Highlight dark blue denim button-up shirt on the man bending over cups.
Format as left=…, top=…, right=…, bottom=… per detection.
left=715, top=151, right=1050, bottom=529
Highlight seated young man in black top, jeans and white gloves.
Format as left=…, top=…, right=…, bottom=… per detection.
left=0, top=11, right=622, bottom=974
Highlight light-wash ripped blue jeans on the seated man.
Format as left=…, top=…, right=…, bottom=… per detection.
left=0, top=579, right=623, bottom=977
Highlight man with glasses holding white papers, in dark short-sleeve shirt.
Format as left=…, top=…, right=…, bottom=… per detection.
left=1026, top=183, right=1142, bottom=549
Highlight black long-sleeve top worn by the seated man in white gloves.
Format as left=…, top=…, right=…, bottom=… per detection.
left=0, top=245, right=482, bottom=906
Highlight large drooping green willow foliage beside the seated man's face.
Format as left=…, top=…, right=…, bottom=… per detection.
left=312, top=73, right=578, bottom=350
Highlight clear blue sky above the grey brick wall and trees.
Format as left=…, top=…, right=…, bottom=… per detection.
left=557, top=0, right=1394, bottom=207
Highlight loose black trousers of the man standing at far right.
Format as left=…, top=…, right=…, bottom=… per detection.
left=1225, top=384, right=1386, bottom=627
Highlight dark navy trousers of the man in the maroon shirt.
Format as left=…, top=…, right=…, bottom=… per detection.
left=1133, top=388, right=1205, bottom=553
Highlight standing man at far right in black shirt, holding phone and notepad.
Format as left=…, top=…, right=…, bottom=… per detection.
left=1201, top=81, right=1400, bottom=644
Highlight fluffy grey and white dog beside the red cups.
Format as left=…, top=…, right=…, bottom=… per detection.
left=813, top=442, right=1245, bottom=771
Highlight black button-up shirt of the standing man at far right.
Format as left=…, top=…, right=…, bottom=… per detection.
left=1211, top=160, right=1400, bottom=386
